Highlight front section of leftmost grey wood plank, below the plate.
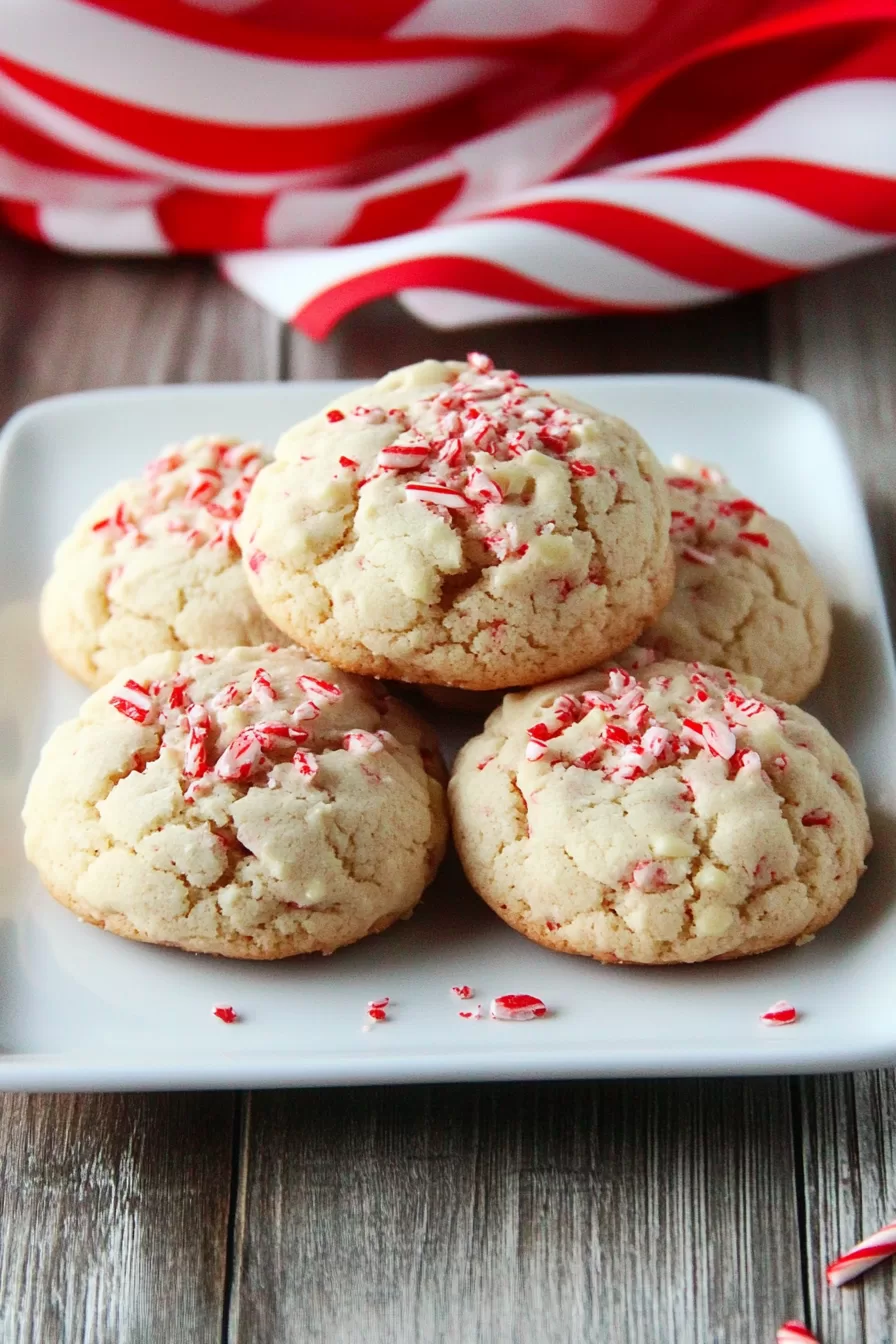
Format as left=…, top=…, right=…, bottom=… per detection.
left=0, top=1094, right=234, bottom=1344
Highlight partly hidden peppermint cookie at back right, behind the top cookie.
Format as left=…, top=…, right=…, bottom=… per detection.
left=641, top=458, right=832, bottom=700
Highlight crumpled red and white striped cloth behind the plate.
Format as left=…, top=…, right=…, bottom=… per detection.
left=0, top=0, right=896, bottom=336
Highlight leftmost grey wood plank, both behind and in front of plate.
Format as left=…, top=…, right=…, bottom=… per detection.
left=0, top=239, right=279, bottom=1344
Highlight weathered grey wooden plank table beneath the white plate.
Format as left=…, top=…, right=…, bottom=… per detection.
left=0, top=241, right=896, bottom=1344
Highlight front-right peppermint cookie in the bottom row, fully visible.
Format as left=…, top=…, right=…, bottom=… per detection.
left=449, top=652, right=870, bottom=964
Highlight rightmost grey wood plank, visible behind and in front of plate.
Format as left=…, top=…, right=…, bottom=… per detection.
left=770, top=254, right=896, bottom=1344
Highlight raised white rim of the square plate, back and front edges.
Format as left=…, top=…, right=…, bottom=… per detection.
left=0, top=372, right=896, bottom=1091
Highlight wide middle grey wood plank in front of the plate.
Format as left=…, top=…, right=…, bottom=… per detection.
left=230, top=1081, right=801, bottom=1344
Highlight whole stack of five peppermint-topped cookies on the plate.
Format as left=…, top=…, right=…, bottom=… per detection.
left=26, top=355, right=869, bottom=962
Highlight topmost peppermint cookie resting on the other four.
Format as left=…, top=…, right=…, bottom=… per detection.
left=239, top=355, right=673, bottom=691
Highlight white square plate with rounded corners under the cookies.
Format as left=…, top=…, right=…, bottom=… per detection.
left=0, top=376, right=896, bottom=1090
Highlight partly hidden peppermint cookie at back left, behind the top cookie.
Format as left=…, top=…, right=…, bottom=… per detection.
left=40, top=435, right=279, bottom=687
